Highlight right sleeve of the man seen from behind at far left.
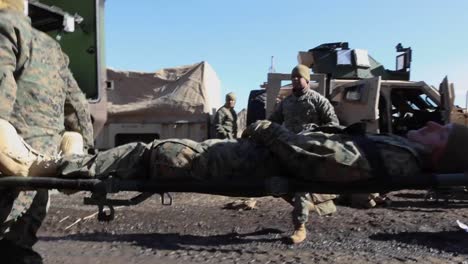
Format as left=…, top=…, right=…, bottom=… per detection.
left=60, top=51, right=94, bottom=151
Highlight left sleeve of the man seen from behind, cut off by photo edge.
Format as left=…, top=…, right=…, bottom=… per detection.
left=0, top=23, right=19, bottom=120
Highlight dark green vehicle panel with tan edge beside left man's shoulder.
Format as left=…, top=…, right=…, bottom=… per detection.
left=29, top=0, right=109, bottom=138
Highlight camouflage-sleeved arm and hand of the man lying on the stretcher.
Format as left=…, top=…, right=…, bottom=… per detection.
left=248, top=120, right=361, bottom=182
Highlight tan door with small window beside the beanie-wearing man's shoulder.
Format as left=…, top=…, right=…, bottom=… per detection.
left=330, top=77, right=380, bottom=132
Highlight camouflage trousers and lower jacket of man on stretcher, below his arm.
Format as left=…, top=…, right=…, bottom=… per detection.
left=59, top=139, right=285, bottom=184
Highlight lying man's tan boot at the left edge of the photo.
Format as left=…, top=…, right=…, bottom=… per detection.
left=0, top=119, right=60, bottom=177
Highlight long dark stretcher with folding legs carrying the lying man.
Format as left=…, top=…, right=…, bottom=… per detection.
left=0, top=172, right=468, bottom=221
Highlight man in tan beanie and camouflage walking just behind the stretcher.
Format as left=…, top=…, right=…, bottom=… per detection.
left=269, top=64, right=339, bottom=243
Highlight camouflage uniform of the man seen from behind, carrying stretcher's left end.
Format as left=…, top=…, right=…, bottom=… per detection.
left=0, top=10, right=93, bottom=248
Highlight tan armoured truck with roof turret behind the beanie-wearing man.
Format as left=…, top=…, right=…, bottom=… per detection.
left=248, top=42, right=467, bottom=135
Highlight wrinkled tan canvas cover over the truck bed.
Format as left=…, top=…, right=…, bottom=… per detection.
left=107, top=62, right=221, bottom=123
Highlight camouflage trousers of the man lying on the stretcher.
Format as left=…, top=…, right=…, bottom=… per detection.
left=58, top=139, right=201, bottom=180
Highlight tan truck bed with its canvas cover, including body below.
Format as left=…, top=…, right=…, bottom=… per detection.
left=95, top=62, right=221, bottom=149
